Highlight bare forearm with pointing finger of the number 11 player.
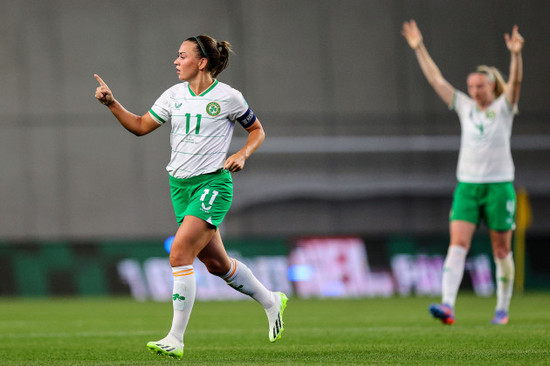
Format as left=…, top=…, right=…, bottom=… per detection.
left=94, top=74, right=160, bottom=136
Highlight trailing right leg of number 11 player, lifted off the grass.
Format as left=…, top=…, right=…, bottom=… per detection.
left=198, top=231, right=287, bottom=342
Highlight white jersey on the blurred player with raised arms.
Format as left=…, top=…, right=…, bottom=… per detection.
left=451, top=90, right=514, bottom=183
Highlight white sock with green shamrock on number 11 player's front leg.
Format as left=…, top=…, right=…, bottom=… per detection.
left=165, top=265, right=197, bottom=344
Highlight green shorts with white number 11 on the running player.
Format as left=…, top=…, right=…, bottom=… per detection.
left=169, top=169, right=233, bottom=228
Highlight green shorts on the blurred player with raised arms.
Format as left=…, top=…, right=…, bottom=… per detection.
left=450, top=182, right=516, bottom=231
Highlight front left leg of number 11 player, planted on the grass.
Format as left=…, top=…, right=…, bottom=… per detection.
left=147, top=216, right=215, bottom=358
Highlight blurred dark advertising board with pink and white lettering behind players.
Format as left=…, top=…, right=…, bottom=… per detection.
left=0, top=236, right=550, bottom=301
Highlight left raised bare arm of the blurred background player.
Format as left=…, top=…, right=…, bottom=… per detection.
left=401, top=20, right=455, bottom=106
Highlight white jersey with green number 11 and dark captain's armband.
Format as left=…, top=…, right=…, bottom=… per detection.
left=149, top=80, right=256, bottom=178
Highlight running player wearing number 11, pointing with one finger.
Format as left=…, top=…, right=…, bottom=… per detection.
left=94, top=35, right=287, bottom=358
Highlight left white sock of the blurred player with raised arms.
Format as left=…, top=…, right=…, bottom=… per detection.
left=441, top=245, right=468, bottom=308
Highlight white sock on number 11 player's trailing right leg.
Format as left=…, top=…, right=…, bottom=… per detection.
left=221, top=258, right=277, bottom=309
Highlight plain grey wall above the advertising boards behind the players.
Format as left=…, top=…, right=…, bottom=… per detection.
left=0, top=0, right=550, bottom=240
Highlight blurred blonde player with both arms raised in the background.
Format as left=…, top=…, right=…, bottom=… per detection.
left=401, top=20, right=523, bottom=324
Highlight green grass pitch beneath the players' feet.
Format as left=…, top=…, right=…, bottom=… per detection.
left=0, top=293, right=550, bottom=365
